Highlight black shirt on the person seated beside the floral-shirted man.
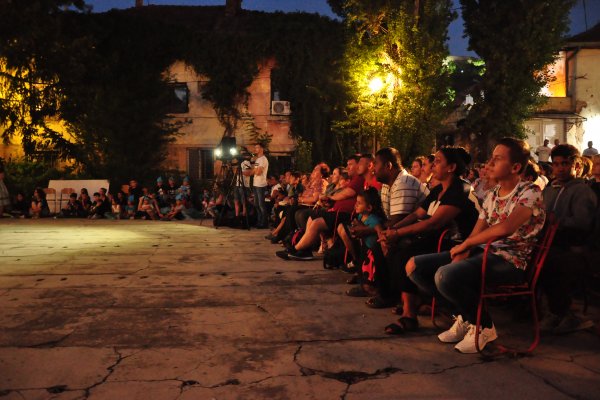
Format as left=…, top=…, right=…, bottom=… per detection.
left=420, top=178, right=479, bottom=239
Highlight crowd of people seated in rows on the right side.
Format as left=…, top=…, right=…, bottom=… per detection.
left=266, top=138, right=600, bottom=353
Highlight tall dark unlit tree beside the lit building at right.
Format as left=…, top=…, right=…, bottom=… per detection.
left=461, top=0, right=574, bottom=148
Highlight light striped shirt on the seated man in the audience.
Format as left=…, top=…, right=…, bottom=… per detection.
left=381, top=169, right=429, bottom=218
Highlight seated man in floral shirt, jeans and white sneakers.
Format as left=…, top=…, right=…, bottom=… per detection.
left=406, top=138, right=545, bottom=353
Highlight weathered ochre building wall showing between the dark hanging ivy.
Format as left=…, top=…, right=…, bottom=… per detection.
left=165, top=60, right=295, bottom=179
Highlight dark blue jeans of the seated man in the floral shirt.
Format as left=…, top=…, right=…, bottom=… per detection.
left=409, top=247, right=525, bottom=328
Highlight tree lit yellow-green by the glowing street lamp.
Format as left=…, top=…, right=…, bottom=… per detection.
left=330, top=0, right=455, bottom=162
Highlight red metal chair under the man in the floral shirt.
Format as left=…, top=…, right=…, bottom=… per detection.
left=475, top=222, right=558, bottom=355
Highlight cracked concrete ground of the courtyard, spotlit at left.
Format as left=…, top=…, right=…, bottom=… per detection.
left=0, top=220, right=600, bottom=400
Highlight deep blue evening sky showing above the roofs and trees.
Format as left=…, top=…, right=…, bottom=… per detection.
left=86, top=0, right=600, bottom=55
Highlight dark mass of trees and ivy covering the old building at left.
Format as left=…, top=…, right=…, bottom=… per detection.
left=0, top=0, right=344, bottom=180
